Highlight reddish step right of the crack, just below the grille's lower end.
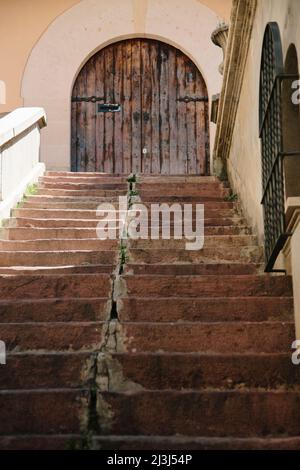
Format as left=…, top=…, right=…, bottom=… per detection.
left=123, top=275, right=293, bottom=298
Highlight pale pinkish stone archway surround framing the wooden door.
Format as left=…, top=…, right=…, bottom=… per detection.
left=22, top=0, right=222, bottom=170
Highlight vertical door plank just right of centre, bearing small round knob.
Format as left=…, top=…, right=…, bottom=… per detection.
left=141, top=40, right=152, bottom=174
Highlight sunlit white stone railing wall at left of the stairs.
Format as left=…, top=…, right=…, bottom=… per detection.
left=0, top=108, right=46, bottom=220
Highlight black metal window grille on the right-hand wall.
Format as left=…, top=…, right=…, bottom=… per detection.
left=259, top=23, right=298, bottom=272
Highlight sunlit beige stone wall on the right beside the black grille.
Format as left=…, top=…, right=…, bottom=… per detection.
left=227, top=0, right=300, bottom=240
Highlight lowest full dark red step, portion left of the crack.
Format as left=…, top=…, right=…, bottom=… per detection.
left=0, top=389, right=89, bottom=435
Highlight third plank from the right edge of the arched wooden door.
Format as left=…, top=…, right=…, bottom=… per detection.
left=177, top=51, right=187, bottom=174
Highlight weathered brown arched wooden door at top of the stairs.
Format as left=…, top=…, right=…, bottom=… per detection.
left=72, top=39, right=209, bottom=175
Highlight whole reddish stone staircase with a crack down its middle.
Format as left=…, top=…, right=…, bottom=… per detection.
left=0, top=172, right=300, bottom=450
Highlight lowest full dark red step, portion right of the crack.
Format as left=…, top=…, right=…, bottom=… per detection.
left=94, top=391, right=300, bottom=438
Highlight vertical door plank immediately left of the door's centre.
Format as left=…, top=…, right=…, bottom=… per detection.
left=132, top=39, right=142, bottom=173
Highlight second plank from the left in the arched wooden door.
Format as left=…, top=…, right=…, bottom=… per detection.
left=85, top=57, right=96, bottom=171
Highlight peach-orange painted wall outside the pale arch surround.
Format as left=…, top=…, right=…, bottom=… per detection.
left=0, top=0, right=232, bottom=113
